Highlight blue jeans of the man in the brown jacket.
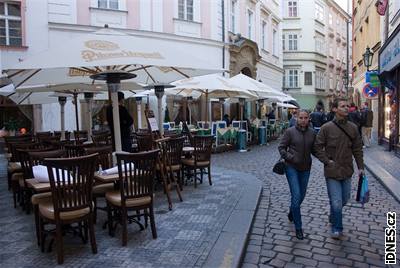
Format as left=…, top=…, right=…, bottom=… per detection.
left=326, top=178, right=351, bottom=232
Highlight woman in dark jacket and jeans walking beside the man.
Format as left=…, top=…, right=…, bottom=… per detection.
left=278, top=110, right=315, bottom=239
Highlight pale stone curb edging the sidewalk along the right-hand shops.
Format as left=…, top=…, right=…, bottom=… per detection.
left=364, top=155, right=400, bottom=202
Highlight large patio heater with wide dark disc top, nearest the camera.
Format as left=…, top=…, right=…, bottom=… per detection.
left=90, top=70, right=136, bottom=152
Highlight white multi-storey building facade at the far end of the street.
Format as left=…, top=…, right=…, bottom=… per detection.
left=282, top=0, right=350, bottom=109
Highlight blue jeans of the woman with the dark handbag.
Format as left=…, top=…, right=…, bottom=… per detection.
left=285, top=166, right=310, bottom=230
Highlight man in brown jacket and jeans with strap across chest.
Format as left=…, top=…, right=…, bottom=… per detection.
left=314, top=99, right=364, bottom=239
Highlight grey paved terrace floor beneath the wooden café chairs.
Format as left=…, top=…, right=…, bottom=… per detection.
left=0, top=155, right=255, bottom=268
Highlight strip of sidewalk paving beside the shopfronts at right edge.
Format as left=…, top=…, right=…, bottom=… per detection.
left=364, top=144, right=400, bottom=180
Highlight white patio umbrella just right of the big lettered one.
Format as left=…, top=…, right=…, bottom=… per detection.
left=166, top=74, right=256, bottom=121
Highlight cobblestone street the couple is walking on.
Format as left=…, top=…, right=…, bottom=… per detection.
left=213, top=142, right=400, bottom=267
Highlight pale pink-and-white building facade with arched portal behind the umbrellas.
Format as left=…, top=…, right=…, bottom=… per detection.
left=0, top=0, right=283, bottom=131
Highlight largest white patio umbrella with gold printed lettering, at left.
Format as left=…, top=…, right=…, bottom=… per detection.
left=3, top=27, right=221, bottom=151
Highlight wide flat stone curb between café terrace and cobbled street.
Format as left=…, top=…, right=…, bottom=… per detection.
left=203, top=173, right=262, bottom=267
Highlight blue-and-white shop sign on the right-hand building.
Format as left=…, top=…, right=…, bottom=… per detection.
left=379, top=31, right=400, bottom=73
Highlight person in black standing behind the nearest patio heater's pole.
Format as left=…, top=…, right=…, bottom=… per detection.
left=107, top=92, right=133, bottom=152
